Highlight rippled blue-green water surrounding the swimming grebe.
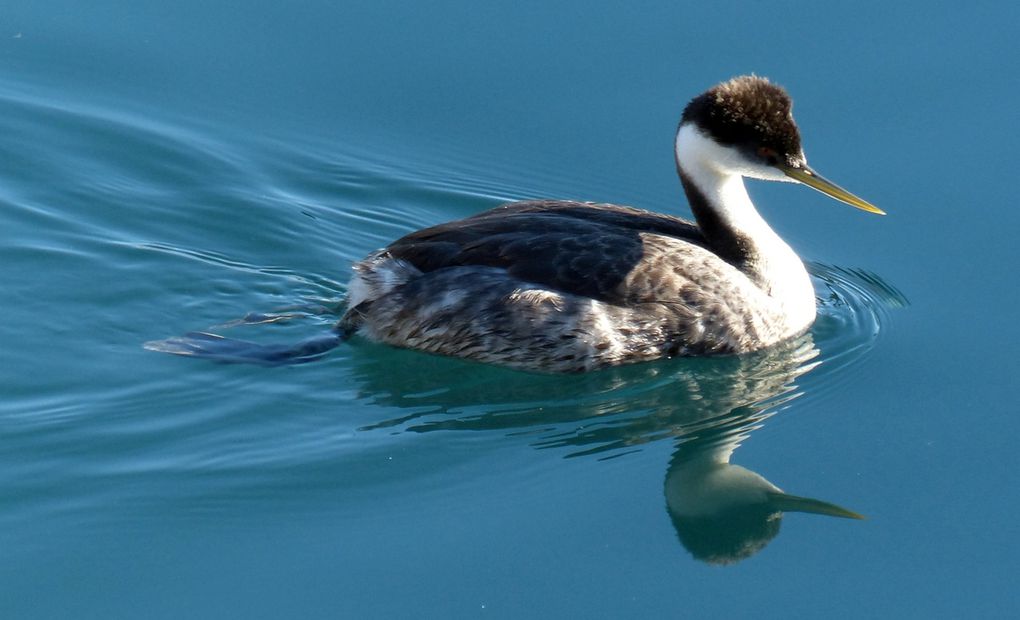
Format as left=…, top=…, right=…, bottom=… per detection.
left=0, top=0, right=1020, bottom=618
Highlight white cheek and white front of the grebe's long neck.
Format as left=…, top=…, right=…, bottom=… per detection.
left=676, top=123, right=815, bottom=327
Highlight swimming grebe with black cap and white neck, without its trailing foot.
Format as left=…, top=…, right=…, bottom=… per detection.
left=339, top=75, right=882, bottom=372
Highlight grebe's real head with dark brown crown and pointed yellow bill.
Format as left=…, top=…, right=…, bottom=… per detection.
left=675, top=75, right=884, bottom=215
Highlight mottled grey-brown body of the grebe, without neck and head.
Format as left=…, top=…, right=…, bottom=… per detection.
left=342, top=201, right=787, bottom=372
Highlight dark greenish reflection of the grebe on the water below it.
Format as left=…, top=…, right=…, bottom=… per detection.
left=353, top=334, right=862, bottom=564
